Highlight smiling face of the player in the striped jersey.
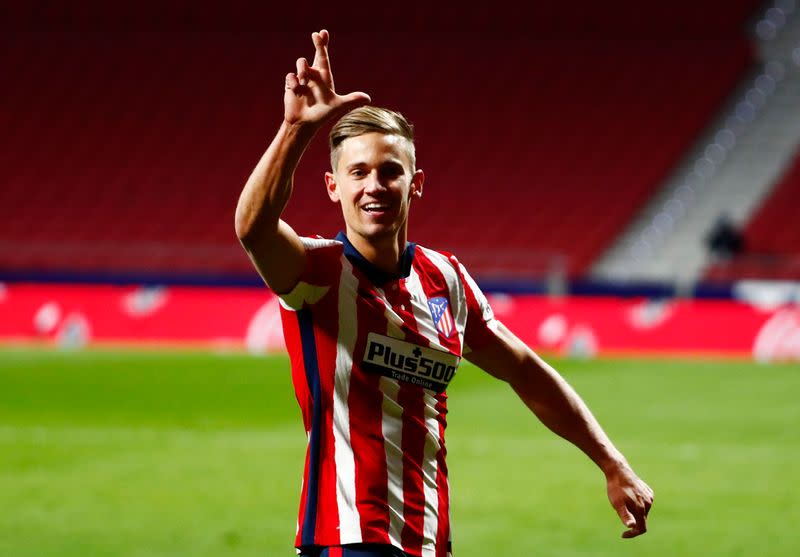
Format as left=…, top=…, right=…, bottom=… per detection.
left=325, top=133, right=424, bottom=240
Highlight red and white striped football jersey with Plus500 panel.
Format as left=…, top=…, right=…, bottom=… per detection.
left=281, top=233, right=496, bottom=557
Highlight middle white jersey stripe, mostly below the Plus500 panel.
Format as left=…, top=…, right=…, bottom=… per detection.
left=380, top=318, right=405, bottom=547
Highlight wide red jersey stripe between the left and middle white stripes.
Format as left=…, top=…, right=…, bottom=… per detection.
left=347, top=268, right=390, bottom=544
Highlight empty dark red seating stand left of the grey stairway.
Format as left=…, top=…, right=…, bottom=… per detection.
left=0, top=24, right=749, bottom=276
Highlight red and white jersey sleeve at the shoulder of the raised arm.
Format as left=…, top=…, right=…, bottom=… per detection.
left=278, top=237, right=342, bottom=311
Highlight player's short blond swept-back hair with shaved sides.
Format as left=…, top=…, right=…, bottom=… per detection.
left=328, top=106, right=417, bottom=172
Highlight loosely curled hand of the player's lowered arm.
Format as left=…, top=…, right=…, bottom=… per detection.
left=606, top=465, right=653, bottom=538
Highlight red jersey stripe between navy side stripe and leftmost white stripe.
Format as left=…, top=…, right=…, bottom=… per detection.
left=311, top=282, right=339, bottom=545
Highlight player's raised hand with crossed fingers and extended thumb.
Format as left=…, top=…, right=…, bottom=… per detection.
left=283, top=29, right=370, bottom=125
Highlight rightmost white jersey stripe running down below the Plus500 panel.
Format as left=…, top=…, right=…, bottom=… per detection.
left=422, top=391, right=442, bottom=557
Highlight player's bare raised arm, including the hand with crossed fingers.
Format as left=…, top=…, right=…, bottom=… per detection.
left=235, top=29, right=370, bottom=293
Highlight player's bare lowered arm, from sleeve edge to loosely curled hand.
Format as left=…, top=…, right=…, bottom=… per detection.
left=466, top=324, right=653, bottom=538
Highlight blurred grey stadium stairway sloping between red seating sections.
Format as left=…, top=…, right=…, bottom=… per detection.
left=592, top=2, right=800, bottom=286
